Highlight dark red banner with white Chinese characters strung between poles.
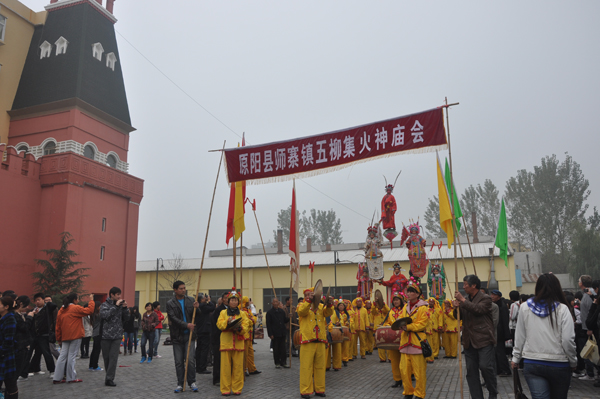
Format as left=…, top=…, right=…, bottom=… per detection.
left=225, top=108, right=447, bottom=183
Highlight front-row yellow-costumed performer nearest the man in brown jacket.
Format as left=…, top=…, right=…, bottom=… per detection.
left=400, top=277, right=428, bottom=399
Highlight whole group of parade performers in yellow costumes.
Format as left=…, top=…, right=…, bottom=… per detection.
left=217, top=264, right=459, bottom=398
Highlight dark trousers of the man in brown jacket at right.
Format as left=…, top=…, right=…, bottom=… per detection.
left=465, top=345, right=498, bottom=399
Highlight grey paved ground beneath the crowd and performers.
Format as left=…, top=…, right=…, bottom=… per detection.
left=19, top=339, right=600, bottom=399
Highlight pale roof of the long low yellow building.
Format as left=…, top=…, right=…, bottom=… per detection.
left=136, top=242, right=500, bottom=272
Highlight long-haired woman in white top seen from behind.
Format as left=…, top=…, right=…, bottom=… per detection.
left=512, top=273, right=577, bottom=399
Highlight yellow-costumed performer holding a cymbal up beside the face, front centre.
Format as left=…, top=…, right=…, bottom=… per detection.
left=298, top=287, right=333, bottom=399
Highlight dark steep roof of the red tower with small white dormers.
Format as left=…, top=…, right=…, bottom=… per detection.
left=12, top=0, right=131, bottom=125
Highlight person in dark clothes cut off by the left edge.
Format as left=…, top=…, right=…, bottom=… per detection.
left=0, top=296, right=19, bottom=399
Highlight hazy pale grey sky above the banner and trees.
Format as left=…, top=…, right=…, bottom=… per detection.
left=21, top=0, right=600, bottom=260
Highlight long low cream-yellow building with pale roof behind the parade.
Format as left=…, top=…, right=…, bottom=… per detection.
left=135, top=237, right=516, bottom=312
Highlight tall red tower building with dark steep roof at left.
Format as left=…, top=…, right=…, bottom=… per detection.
left=0, top=0, right=144, bottom=302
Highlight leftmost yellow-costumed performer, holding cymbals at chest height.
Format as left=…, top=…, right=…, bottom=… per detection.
left=217, top=287, right=249, bottom=396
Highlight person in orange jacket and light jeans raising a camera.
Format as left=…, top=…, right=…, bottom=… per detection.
left=53, top=293, right=96, bottom=384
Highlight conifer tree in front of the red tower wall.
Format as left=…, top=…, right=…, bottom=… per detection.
left=32, top=231, right=89, bottom=302
